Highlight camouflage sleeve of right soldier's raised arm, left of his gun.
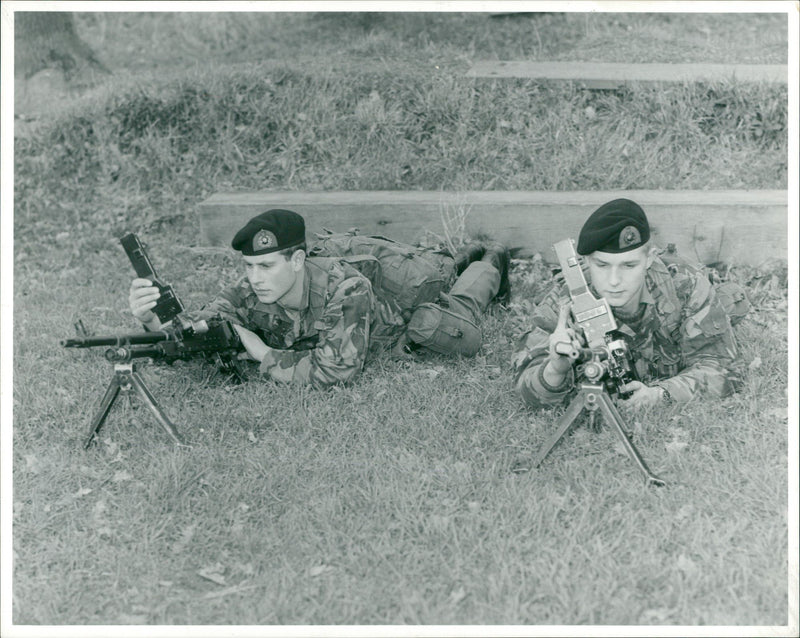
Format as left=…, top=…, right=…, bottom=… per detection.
left=511, top=284, right=575, bottom=407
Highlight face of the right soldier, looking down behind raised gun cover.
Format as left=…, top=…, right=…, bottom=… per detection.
left=586, top=245, right=653, bottom=311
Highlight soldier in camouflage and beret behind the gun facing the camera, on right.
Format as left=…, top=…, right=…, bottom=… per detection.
left=513, top=199, right=743, bottom=407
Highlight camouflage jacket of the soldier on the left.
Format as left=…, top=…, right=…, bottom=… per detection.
left=194, top=257, right=405, bottom=387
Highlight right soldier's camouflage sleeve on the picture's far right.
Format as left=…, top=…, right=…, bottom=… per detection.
left=658, top=272, right=737, bottom=403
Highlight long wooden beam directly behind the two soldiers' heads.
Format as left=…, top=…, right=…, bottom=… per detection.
left=199, top=190, right=788, bottom=265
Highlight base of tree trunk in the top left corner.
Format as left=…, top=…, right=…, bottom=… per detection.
left=14, top=11, right=110, bottom=80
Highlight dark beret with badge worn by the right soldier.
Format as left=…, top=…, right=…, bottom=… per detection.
left=577, top=199, right=650, bottom=255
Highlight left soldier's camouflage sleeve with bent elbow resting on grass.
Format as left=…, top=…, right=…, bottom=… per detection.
left=259, top=277, right=374, bottom=387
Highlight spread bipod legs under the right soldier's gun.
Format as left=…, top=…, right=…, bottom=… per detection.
left=514, top=383, right=666, bottom=487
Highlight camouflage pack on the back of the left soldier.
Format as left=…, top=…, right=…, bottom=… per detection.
left=308, top=228, right=455, bottom=311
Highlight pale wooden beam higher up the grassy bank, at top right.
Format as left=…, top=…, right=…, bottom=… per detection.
left=467, top=60, right=789, bottom=89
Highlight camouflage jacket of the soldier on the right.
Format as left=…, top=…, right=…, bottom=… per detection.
left=512, top=258, right=736, bottom=406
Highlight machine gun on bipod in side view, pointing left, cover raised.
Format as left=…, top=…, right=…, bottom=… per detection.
left=61, top=234, right=244, bottom=448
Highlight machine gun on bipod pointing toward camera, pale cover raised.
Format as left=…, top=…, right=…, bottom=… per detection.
left=515, top=239, right=666, bottom=487
